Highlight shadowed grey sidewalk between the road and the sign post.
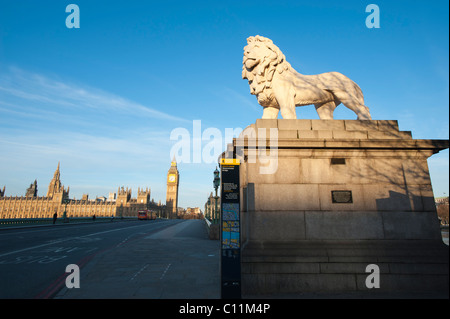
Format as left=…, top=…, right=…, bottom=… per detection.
left=55, top=220, right=220, bottom=299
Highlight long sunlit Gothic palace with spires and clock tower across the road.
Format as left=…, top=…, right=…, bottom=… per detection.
left=0, top=159, right=179, bottom=219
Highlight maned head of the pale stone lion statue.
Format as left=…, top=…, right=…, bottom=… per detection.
left=242, top=35, right=290, bottom=106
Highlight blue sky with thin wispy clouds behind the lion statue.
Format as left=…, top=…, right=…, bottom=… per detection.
left=0, top=0, right=449, bottom=209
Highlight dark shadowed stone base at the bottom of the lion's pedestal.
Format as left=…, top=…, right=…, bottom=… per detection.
left=242, top=240, right=449, bottom=298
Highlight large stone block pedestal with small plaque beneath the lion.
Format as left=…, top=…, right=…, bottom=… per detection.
left=224, top=119, right=449, bottom=298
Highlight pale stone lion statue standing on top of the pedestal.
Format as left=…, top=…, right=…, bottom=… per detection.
left=242, top=35, right=372, bottom=120
